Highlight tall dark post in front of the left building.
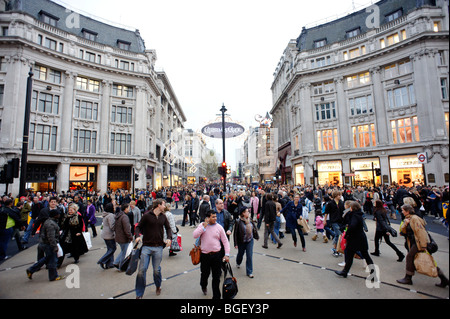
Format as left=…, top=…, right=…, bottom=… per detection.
left=19, top=67, right=33, bottom=196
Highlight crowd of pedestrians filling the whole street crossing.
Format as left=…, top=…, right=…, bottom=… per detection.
left=0, top=184, right=449, bottom=298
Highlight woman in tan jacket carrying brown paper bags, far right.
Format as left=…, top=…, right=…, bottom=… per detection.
left=397, top=204, right=448, bottom=288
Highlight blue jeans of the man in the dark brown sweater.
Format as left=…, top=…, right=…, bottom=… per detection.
left=136, top=246, right=163, bottom=297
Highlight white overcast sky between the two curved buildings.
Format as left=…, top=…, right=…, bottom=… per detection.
left=55, top=0, right=371, bottom=169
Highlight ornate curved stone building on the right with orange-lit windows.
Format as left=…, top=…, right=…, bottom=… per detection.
left=270, top=0, right=449, bottom=186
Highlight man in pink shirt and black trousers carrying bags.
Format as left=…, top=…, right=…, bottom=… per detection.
left=194, top=210, right=230, bottom=299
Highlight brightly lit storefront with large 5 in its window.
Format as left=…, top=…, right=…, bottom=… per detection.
left=389, top=154, right=424, bottom=187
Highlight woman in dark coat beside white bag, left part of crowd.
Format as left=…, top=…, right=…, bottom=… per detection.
left=58, top=204, right=88, bottom=265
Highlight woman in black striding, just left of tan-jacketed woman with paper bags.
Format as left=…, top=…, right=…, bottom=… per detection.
left=370, top=199, right=405, bottom=262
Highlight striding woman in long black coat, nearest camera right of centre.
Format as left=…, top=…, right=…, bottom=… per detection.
left=335, top=202, right=373, bottom=278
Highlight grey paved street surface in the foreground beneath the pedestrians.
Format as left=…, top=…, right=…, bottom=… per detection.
left=0, top=215, right=449, bottom=300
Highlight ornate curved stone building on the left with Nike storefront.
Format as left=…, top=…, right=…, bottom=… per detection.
left=0, top=0, right=186, bottom=194
